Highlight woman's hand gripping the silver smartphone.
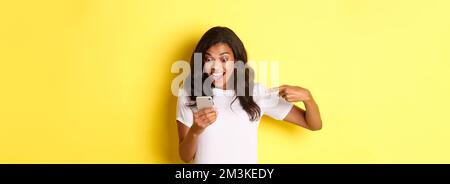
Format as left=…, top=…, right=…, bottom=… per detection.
left=190, top=107, right=217, bottom=135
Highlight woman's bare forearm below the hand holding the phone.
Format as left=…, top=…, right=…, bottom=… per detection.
left=179, top=131, right=198, bottom=162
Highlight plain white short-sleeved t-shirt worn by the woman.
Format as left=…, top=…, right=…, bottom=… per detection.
left=177, top=84, right=293, bottom=164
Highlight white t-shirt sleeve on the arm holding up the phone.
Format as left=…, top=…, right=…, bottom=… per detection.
left=176, top=89, right=194, bottom=127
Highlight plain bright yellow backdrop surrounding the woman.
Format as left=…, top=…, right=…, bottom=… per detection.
left=0, top=0, right=450, bottom=163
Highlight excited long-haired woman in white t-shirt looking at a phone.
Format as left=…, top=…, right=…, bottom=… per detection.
left=176, top=27, right=322, bottom=163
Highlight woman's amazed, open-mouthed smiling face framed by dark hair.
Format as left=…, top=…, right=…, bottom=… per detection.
left=204, top=43, right=234, bottom=89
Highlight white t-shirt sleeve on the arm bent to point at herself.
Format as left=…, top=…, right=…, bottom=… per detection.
left=254, top=84, right=293, bottom=120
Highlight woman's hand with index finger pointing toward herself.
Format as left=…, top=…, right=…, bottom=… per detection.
left=276, top=85, right=313, bottom=102
